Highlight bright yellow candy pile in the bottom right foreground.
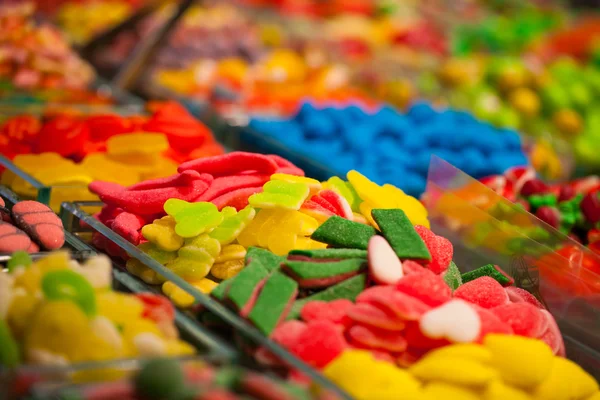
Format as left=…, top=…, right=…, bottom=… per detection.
left=324, top=334, right=600, bottom=400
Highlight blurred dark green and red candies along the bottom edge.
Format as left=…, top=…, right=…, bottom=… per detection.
left=35, top=358, right=336, bottom=400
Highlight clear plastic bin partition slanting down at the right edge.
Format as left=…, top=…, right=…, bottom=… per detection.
left=423, top=157, right=600, bottom=378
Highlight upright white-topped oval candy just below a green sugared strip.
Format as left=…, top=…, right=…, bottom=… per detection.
left=368, top=235, right=404, bottom=285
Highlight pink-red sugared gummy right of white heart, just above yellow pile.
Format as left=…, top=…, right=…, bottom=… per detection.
left=492, top=303, right=548, bottom=338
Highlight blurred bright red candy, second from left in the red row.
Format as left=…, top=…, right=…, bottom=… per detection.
left=37, top=115, right=90, bottom=157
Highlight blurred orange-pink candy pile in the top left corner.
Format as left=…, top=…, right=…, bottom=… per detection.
left=0, top=3, right=94, bottom=90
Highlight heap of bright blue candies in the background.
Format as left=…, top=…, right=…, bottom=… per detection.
left=250, top=103, right=527, bottom=195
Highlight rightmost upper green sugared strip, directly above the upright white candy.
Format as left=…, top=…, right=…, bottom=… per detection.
left=371, top=208, right=431, bottom=260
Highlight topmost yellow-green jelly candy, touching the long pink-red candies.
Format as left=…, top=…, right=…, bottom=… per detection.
left=248, top=180, right=310, bottom=210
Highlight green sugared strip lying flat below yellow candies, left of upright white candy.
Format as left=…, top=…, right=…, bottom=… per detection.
left=311, top=215, right=376, bottom=250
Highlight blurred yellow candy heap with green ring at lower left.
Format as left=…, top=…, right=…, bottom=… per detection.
left=0, top=252, right=194, bottom=366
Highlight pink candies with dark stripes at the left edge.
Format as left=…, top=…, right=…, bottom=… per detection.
left=0, top=197, right=65, bottom=254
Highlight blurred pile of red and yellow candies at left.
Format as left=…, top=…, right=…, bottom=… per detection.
left=0, top=103, right=223, bottom=210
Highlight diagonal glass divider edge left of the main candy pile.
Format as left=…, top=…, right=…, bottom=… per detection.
left=60, top=202, right=350, bottom=399
